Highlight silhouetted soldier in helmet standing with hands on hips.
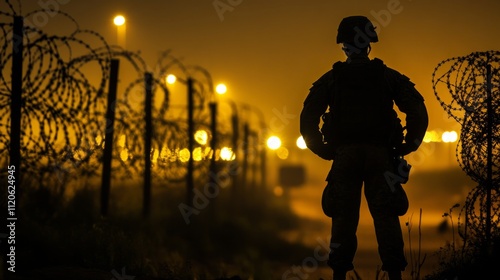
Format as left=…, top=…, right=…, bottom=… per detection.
left=300, top=16, right=428, bottom=280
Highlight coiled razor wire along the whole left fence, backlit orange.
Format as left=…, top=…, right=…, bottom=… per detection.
left=0, top=1, right=227, bottom=185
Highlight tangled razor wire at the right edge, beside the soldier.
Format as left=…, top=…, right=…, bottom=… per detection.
left=432, top=51, right=500, bottom=250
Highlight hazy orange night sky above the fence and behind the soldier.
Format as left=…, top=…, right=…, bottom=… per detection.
left=15, top=0, right=500, bottom=136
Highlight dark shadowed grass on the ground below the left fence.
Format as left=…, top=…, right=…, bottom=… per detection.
left=8, top=176, right=311, bottom=279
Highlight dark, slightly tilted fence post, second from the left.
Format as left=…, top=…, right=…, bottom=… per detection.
left=101, top=59, right=120, bottom=217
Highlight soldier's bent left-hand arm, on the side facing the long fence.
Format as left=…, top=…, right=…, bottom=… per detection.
left=300, top=73, right=330, bottom=159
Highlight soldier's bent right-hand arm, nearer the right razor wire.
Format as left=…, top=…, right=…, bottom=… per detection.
left=387, top=69, right=429, bottom=154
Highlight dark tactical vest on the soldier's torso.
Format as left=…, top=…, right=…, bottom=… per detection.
left=325, top=59, right=403, bottom=151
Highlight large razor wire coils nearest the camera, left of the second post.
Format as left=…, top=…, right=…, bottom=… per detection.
left=0, top=8, right=114, bottom=182
